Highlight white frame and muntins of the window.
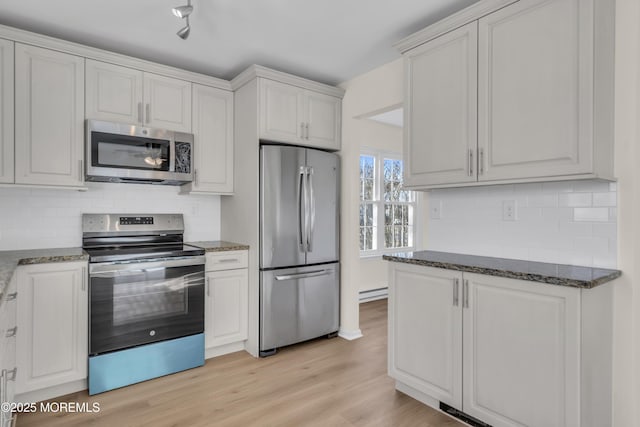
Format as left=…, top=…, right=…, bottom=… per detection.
left=358, top=148, right=421, bottom=258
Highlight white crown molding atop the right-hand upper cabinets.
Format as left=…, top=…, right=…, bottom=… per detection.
left=393, top=0, right=518, bottom=53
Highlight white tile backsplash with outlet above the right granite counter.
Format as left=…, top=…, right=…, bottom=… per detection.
left=425, top=181, right=617, bottom=268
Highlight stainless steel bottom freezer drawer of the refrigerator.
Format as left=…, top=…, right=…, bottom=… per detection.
left=260, top=263, right=340, bottom=351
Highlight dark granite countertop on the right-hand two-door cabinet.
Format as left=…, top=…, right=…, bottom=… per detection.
left=382, top=251, right=622, bottom=289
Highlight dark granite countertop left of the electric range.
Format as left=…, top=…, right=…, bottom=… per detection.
left=0, top=248, right=89, bottom=304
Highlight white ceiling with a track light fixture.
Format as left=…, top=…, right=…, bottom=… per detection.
left=0, top=0, right=477, bottom=84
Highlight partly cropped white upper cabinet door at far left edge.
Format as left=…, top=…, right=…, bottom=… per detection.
left=0, top=39, right=14, bottom=183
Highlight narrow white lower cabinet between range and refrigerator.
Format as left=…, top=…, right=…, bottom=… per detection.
left=204, top=251, right=249, bottom=357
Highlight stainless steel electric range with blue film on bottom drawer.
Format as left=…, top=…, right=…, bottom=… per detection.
left=82, top=214, right=205, bottom=394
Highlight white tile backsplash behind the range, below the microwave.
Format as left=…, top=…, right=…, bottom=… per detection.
left=0, top=183, right=220, bottom=250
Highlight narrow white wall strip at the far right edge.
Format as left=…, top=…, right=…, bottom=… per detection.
left=613, top=0, right=640, bottom=427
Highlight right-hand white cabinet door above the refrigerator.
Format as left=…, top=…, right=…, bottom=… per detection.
left=304, top=90, right=342, bottom=150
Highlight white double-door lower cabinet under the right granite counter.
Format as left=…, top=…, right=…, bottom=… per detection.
left=389, top=262, right=611, bottom=427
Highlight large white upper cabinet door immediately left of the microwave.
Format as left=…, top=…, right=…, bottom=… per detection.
left=15, top=43, right=84, bottom=186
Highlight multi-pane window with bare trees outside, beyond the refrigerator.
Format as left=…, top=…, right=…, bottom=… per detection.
left=360, top=152, right=416, bottom=255
